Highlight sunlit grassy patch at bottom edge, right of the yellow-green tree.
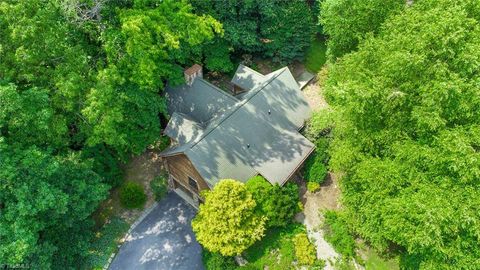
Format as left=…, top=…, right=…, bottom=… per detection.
left=244, top=223, right=305, bottom=270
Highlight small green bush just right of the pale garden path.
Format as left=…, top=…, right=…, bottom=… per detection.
left=324, top=211, right=355, bottom=258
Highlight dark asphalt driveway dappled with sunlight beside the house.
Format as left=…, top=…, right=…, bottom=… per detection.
left=109, top=192, right=204, bottom=270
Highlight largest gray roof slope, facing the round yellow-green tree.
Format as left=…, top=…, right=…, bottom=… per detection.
left=162, top=68, right=314, bottom=186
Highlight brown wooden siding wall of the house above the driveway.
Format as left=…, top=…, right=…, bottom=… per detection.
left=165, top=154, right=210, bottom=193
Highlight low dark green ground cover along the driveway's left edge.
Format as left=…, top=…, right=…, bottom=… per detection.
left=82, top=218, right=130, bottom=269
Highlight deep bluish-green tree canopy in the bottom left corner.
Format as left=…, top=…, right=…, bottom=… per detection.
left=0, top=143, right=107, bottom=269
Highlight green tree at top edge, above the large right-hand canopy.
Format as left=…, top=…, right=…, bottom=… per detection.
left=320, top=0, right=405, bottom=60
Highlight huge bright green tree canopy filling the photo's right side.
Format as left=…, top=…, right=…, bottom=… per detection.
left=327, top=0, right=480, bottom=269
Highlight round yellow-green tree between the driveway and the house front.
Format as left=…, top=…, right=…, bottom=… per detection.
left=192, top=179, right=265, bottom=256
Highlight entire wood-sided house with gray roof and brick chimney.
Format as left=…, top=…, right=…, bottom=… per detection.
left=161, top=65, right=315, bottom=207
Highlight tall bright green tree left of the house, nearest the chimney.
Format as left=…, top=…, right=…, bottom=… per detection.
left=82, top=0, right=222, bottom=154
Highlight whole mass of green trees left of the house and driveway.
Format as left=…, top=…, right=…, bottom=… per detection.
left=0, top=0, right=222, bottom=269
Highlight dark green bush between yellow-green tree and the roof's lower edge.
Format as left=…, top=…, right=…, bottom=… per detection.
left=246, top=176, right=299, bottom=227
